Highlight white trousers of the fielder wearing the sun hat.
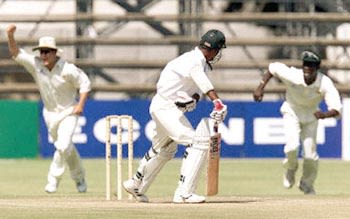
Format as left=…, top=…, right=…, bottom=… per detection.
left=43, top=109, right=85, bottom=183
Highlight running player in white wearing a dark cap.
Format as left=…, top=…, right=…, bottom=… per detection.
left=253, top=51, right=342, bottom=194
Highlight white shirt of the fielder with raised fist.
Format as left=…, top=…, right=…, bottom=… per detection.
left=14, top=49, right=91, bottom=112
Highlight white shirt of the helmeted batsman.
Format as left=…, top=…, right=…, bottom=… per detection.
left=157, top=47, right=214, bottom=102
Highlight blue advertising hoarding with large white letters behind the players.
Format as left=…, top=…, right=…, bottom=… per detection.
left=40, top=99, right=341, bottom=158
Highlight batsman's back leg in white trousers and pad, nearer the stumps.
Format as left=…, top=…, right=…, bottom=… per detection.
left=135, top=95, right=194, bottom=194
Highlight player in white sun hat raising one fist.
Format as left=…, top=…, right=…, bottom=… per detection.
left=7, top=25, right=91, bottom=193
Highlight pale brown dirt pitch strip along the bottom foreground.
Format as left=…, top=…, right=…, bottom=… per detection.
left=0, top=196, right=350, bottom=219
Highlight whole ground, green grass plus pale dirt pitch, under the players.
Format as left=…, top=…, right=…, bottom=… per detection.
left=0, top=159, right=350, bottom=219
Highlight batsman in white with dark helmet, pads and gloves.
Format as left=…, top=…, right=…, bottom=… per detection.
left=123, top=29, right=227, bottom=203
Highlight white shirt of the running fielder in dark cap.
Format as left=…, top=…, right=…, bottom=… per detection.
left=269, top=62, right=342, bottom=113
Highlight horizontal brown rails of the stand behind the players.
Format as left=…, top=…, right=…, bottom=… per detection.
left=0, top=13, right=350, bottom=93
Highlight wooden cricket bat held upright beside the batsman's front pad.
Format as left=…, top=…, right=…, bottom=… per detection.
left=207, top=122, right=221, bottom=196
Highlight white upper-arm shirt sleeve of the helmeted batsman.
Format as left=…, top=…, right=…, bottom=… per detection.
left=190, top=64, right=214, bottom=94
